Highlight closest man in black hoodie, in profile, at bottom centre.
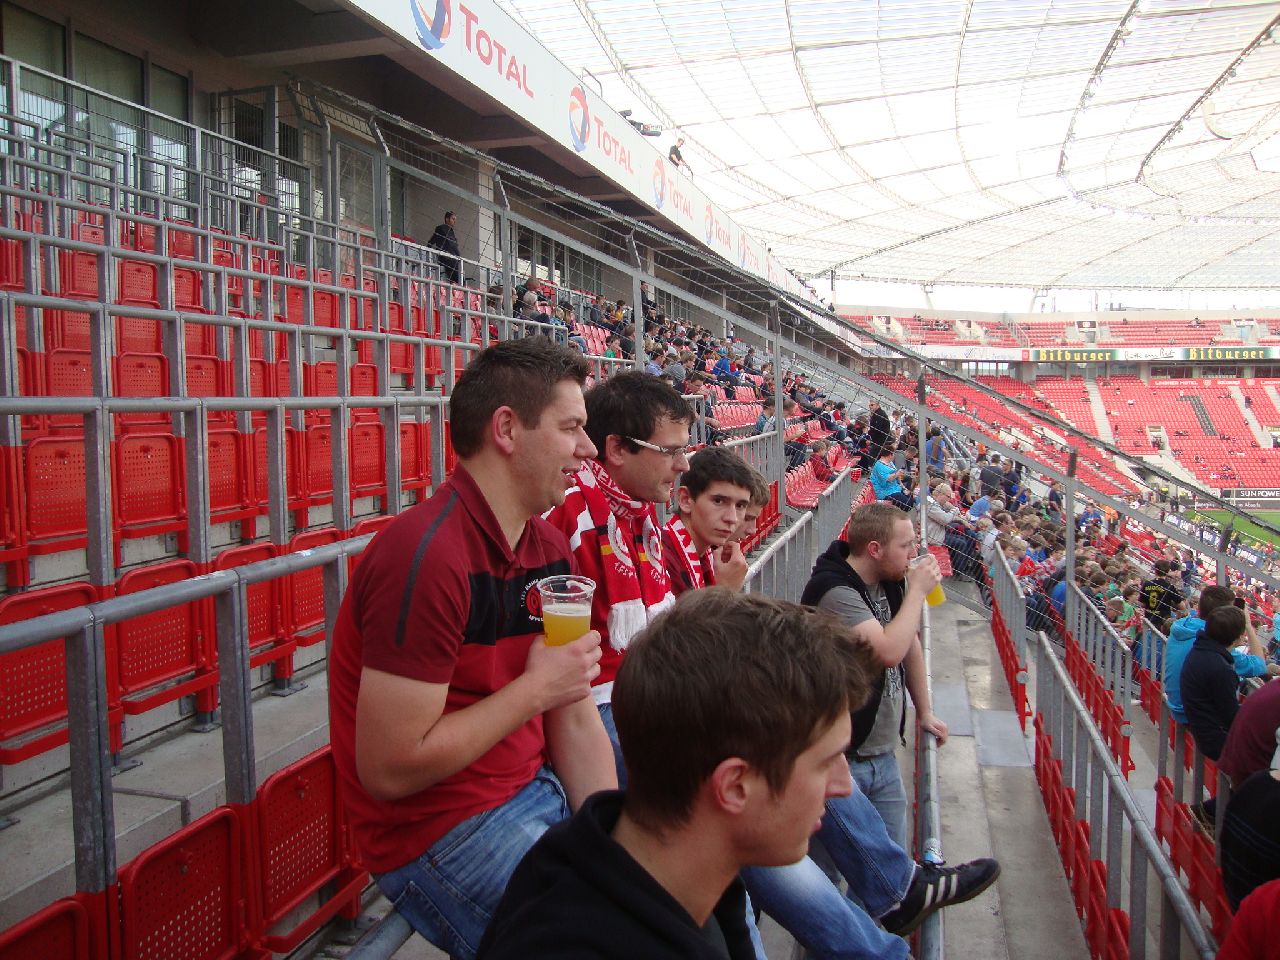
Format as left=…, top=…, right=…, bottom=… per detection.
left=479, top=590, right=872, bottom=960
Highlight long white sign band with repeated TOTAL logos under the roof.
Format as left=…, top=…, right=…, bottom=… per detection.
left=347, top=0, right=809, bottom=298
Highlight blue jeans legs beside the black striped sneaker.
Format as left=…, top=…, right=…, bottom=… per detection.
left=742, top=788, right=915, bottom=960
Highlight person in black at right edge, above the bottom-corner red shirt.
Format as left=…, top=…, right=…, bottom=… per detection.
left=1217, top=750, right=1280, bottom=911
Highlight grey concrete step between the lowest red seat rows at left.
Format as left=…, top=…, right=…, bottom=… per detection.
left=0, top=664, right=329, bottom=929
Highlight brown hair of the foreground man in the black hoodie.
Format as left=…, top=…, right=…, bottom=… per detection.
left=613, top=588, right=882, bottom=831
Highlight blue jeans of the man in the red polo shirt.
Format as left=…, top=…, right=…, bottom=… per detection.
left=378, top=767, right=570, bottom=960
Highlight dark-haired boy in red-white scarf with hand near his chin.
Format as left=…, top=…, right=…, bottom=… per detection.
left=662, top=447, right=747, bottom=596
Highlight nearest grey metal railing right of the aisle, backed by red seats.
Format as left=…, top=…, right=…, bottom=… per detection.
left=1034, top=632, right=1216, bottom=960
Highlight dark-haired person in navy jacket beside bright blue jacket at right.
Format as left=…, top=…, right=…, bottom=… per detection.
left=1180, top=605, right=1248, bottom=760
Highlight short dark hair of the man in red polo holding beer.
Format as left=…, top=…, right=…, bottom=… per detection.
left=449, top=337, right=591, bottom=458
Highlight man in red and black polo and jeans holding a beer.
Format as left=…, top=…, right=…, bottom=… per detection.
left=329, top=337, right=617, bottom=957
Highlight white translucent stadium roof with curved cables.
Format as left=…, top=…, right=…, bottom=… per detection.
left=499, top=0, right=1280, bottom=289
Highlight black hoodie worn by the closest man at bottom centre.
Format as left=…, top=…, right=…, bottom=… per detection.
left=476, top=790, right=755, bottom=960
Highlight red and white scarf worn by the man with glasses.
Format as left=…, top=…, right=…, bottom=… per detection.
left=552, top=460, right=676, bottom=682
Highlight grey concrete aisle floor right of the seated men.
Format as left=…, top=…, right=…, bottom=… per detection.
left=931, top=580, right=1088, bottom=960
